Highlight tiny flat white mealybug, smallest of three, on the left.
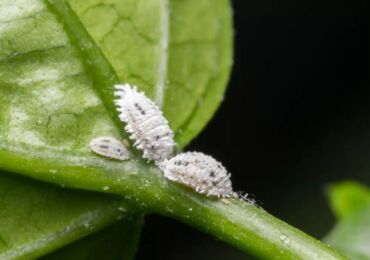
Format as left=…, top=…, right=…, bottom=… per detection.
left=90, top=136, right=129, bottom=161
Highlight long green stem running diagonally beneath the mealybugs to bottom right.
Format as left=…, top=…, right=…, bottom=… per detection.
left=0, top=147, right=345, bottom=260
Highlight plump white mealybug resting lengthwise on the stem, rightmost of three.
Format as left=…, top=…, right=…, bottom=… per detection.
left=159, top=152, right=234, bottom=197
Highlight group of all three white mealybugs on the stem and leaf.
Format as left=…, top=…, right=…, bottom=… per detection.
left=90, top=84, right=235, bottom=198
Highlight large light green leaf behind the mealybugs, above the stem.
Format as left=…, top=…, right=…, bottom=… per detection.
left=0, top=0, right=231, bottom=169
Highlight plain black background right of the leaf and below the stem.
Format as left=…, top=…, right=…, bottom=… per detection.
left=137, top=0, right=370, bottom=260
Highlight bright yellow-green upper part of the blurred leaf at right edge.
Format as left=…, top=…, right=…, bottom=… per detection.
left=328, top=181, right=370, bottom=219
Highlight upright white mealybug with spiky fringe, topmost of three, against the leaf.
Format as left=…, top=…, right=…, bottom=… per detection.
left=114, top=84, right=175, bottom=162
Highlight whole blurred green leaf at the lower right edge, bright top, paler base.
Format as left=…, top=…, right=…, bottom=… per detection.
left=325, top=182, right=370, bottom=260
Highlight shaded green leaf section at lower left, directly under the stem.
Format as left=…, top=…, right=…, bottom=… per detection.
left=0, top=172, right=140, bottom=259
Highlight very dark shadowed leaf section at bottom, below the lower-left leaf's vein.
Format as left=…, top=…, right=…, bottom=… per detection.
left=40, top=219, right=142, bottom=260
